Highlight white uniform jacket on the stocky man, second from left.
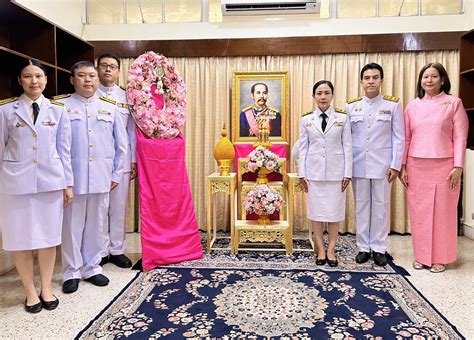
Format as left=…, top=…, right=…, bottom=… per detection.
left=56, top=93, right=127, bottom=195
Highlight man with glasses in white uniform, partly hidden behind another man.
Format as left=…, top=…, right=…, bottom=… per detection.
left=97, top=53, right=137, bottom=268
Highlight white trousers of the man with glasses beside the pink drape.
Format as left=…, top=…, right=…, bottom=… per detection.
left=101, top=172, right=130, bottom=257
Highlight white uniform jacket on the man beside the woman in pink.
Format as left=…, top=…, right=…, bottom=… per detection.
left=346, top=95, right=405, bottom=179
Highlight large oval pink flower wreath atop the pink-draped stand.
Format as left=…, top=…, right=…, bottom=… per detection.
left=127, top=52, right=186, bottom=139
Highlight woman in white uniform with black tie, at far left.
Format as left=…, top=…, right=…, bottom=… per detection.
left=0, top=60, right=73, bottom=313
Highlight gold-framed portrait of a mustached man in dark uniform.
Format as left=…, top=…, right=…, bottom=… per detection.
left=231, top=71, right=290, bottom=143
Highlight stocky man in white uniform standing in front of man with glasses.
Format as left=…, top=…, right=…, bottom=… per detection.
left=56, top=61, right=127, bottom=293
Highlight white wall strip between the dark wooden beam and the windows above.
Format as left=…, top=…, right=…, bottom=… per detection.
left=84, top=12, right=474, bottom=40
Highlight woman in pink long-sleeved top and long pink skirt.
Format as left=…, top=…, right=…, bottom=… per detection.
left=400, top=63, right=469, bottom=273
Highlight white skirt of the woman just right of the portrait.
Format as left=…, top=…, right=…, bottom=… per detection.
left=306, top=180, right=346, bottom=222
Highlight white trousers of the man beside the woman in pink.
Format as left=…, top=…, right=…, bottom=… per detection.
left=352, top=177, right=392, bottom=254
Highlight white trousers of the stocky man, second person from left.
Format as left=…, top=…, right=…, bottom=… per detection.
left=61, top=192, right=109, bottom=281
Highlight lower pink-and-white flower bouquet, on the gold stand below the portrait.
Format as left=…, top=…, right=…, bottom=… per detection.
left=244, top=184, right=283, bottom=215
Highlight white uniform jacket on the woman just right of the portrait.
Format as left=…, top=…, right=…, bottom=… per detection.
left=298, top=106, right=352, bottom=181
